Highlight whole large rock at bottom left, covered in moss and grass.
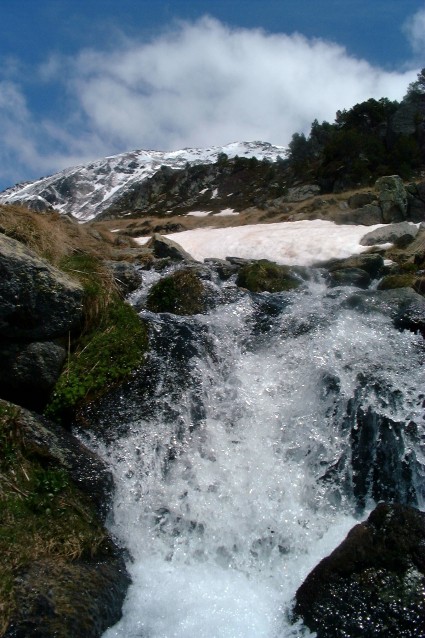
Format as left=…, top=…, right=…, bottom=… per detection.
left=0, top=401, right=129, bottom=638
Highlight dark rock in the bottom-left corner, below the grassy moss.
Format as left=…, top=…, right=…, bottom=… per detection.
left=4, top=552, right=130, bottom=638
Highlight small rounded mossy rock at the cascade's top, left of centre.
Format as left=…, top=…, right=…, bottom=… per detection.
left=146, top=268, right=206, bottom=315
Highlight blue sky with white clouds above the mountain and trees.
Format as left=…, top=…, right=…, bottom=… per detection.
left=0, top=0, right=425, bottom=190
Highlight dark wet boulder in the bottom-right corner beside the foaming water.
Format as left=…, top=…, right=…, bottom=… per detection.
left=294, top=503, right=425, bottom=638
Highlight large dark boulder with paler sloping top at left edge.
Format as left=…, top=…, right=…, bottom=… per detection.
left=0, top=235, right=83, bottom=341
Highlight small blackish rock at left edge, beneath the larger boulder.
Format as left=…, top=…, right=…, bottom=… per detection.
left=0, top=341, right=66, bottom=410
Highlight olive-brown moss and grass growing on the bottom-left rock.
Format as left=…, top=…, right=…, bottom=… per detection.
left=0, top=401, right=107, bottom=635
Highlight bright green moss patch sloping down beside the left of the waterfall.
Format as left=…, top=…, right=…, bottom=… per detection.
left=45, top=299, right=148, bottom=420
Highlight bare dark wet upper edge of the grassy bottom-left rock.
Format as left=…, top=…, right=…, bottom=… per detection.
left=11, top=408, right=113, bottom=518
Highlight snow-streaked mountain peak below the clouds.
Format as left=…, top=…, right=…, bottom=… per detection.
left=0, top=142, right=285, bottom=221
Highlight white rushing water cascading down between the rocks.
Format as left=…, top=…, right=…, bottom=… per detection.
left=81, top=270, right=425, bottom=638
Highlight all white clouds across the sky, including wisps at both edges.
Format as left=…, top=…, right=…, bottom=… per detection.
left=0, top=12, right=425, bottom=189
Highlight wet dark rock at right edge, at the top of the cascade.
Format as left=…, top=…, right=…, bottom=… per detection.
left=343, top=288, right=425, bottom=336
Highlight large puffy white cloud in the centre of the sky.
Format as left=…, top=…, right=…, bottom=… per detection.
left=66, top=18, right=416, bottom=150
